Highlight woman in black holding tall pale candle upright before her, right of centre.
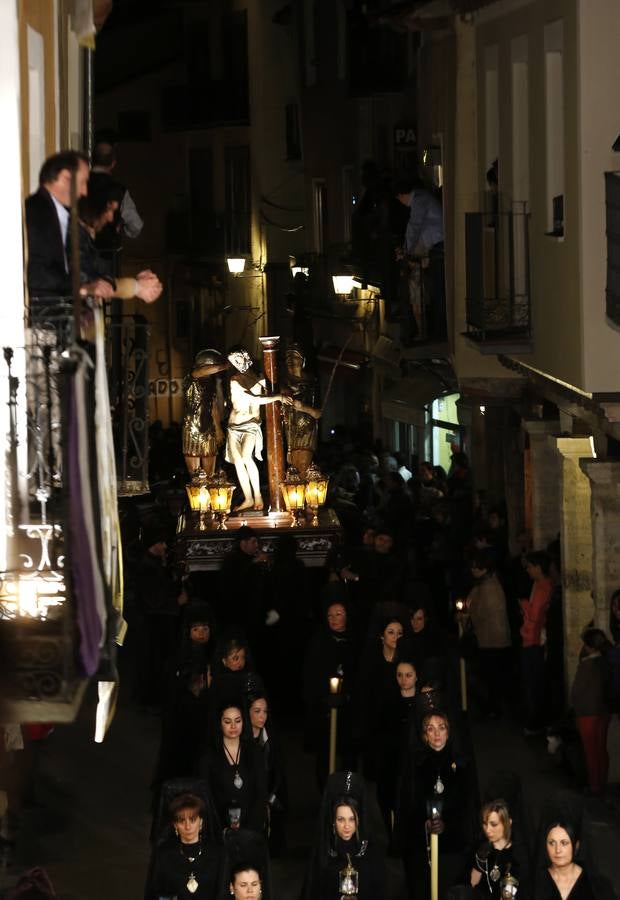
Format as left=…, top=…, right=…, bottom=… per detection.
left=396, top=712, right=478, bottom=900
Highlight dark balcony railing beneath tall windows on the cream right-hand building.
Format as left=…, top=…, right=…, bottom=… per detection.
left=465, top=210, right=531, bottom=342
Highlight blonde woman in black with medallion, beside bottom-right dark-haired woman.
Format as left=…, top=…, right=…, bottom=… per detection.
left=470, top=799, right=530, bottom=898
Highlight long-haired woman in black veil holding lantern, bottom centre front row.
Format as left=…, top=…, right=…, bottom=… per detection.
left=302, top=772, right=386, bottom=900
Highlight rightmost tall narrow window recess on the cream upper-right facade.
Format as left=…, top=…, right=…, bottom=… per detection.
left=545, top=20, right=564, bottom=237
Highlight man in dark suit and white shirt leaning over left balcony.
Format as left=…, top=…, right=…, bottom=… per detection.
left=26, top=150, right=113, bottom=303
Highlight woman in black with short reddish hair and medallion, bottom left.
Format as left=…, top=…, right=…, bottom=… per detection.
left=145, top=782, right=226, bottom=900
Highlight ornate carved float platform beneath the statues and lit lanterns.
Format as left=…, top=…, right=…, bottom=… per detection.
left=177, top=509, right=342, bottom=572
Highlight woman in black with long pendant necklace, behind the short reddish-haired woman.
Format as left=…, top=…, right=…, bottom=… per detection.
left=200, top=702, right=267, bottom=832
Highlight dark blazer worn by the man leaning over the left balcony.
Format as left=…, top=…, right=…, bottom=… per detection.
left=26, top=187, right=71, bottom=298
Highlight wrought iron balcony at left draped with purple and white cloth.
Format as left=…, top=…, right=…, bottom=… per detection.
left=0, top=298, right=148, bottom=722
